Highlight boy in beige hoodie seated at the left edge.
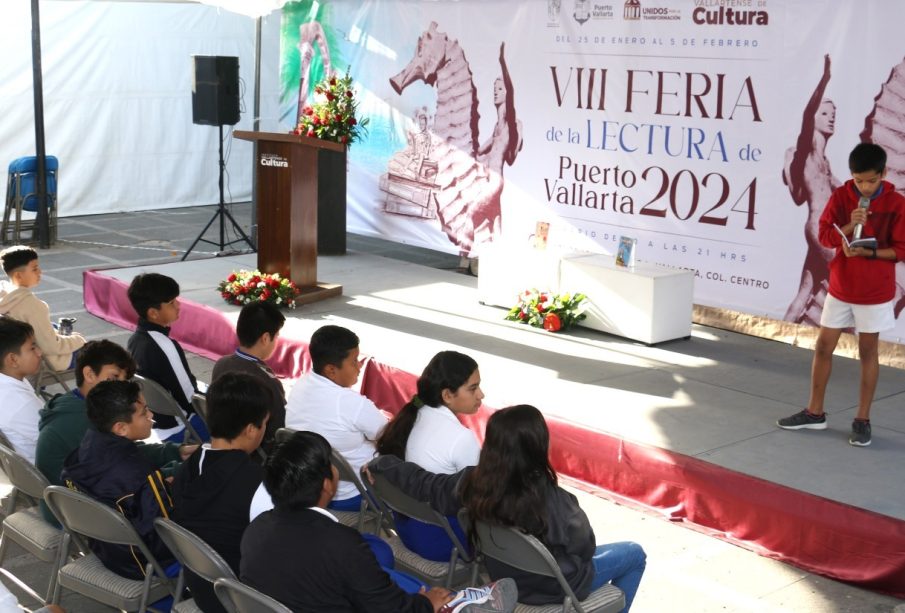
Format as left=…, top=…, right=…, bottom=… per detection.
left=0, top=245, right=85, bottom=370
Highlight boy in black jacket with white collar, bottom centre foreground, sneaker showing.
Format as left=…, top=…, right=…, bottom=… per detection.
left=239, top=432, right=516, bottom=613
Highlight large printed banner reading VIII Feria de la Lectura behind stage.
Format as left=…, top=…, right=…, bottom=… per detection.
left=281, top=0, right=905, bottom=342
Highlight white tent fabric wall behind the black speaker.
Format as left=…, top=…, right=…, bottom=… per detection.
left=0, top=1, right=280, bottom=216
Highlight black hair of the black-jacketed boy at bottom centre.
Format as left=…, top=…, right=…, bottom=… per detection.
left=264, top=432, right=333, bottom=511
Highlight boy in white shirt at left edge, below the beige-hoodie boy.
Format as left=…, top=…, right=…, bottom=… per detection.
left=0, top=317, right=41, bottom=462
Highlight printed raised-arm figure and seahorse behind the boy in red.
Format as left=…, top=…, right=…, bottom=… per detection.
left=782, top=55, right=905, bottom=326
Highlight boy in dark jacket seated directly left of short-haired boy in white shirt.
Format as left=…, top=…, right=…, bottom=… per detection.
left=211, top=301, right=286, bottom=451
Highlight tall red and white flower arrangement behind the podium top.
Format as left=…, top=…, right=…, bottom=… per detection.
left=293, top=72, right=368, bottom=145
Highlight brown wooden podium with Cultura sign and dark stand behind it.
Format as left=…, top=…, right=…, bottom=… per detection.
left=233, top=130, right=346, bottom=304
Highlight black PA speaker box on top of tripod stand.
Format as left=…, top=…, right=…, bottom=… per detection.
left=192, top=55, right=239, bottom=126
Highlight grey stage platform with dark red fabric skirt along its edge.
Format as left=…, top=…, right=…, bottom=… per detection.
left=84, top=253, right=905, bottom=598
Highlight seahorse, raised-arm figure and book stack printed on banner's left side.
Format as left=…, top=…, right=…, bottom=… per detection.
left=380, top=22, right=522, bottom=255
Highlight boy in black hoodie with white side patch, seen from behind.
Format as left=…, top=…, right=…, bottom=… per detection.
left=172, top=372, right=272, bottom=613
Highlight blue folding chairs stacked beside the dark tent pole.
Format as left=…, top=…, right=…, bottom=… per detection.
left=0, top=155, right=60, bottom=243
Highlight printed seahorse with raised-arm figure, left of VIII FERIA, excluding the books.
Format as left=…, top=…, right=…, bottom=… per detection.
left=390, top=22, right=522, bottom=254
